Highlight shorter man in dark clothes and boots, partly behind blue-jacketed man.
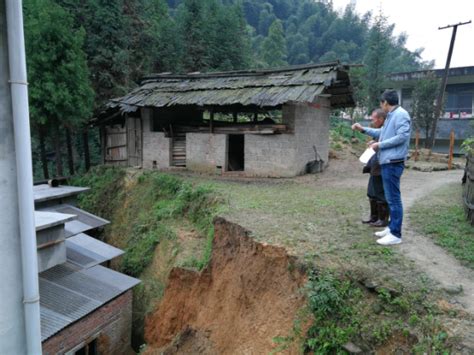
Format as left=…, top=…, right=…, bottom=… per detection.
left=362, top=109, right=388, bottom=227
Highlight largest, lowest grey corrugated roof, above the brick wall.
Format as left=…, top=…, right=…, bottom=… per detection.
left=39, top=263, right=140, bottom=341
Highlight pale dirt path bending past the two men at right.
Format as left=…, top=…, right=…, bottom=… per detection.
left=400, top=170, right=474, bottom=314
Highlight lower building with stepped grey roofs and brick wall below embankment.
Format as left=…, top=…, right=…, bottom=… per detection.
left=34, top=185, right=139, bottom=355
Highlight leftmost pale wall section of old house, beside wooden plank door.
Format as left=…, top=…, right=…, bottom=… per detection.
left=141, top=108, right=171, bottom=169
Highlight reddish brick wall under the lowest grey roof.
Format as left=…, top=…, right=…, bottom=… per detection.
left=43, top=290, right=132, bottom=355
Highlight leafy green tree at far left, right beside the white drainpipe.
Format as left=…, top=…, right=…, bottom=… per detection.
left=25, top=0, right=94, bottom=177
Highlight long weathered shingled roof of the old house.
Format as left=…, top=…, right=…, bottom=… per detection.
left=108, top=62, right=353, bottom=112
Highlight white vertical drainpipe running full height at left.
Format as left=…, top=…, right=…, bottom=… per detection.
left=6, top=0, right=41, bottom=355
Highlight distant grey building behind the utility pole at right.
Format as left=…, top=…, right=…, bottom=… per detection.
left=388, top=66, right=474, bottom=152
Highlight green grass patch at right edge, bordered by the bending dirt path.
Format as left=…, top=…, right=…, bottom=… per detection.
left=411, top=184, right=474, bottom=269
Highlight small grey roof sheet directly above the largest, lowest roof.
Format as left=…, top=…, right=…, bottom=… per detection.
left=66, top=233, right=124, bottom=268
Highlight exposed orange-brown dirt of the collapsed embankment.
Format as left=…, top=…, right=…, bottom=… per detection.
left=145, top=218, right=305, bottom=354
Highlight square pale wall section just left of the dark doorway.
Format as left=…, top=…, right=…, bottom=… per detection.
left=186, top=133, right=227, bottom=173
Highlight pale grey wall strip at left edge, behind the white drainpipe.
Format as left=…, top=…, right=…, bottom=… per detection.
left=0, top=0, right=26, bottom=354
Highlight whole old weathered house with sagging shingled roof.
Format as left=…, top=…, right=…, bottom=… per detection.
left=97, top=62, right=354, bottom=177
